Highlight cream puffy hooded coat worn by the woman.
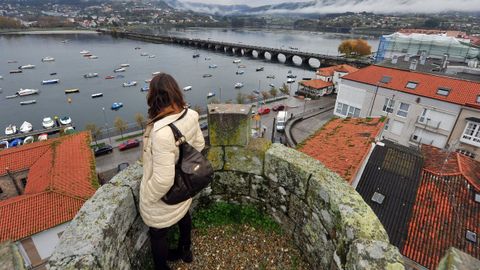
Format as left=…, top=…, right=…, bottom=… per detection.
left=140, top=110, right=205, bottom=228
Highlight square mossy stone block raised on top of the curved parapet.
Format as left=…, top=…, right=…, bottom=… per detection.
left=208, top=104, right=252, bottom=146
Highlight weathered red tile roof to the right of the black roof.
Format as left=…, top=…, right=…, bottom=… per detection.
left=402, top=145, right=480, bottom=269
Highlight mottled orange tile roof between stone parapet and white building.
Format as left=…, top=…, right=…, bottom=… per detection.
left=299, top=118, right=383, bottom=184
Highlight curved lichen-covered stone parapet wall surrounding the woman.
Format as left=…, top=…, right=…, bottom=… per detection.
left=49, top=105, right=404, bottom=269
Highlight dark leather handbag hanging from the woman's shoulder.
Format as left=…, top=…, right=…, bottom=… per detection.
left=162, top=109, right=213, bottom=205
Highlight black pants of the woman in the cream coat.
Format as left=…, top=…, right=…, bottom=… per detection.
left=149, top=212, right=192, bottom=270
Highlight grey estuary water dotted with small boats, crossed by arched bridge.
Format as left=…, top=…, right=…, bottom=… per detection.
left=0, top=29, right=376, bottom=132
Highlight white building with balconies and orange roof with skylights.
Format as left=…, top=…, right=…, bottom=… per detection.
left=334, top=66, right=480, bottom=156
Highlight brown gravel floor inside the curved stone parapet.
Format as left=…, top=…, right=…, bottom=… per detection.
left=171, top=225, right=311, bottom=270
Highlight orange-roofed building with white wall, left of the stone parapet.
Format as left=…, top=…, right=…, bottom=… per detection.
left=0, top=132, right=98, bottom=269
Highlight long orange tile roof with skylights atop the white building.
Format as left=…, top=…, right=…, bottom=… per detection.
left=342, top=65, right=480, bottom=105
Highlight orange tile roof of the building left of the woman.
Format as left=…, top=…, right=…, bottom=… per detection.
left=0, top=132, right=95, bottom=242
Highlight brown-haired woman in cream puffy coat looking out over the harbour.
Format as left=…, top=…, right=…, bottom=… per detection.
left=140, top=73, right=205, bottom=270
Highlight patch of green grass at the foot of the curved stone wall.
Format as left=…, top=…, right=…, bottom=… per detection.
left=193, top=202, right=281, bottom=233
